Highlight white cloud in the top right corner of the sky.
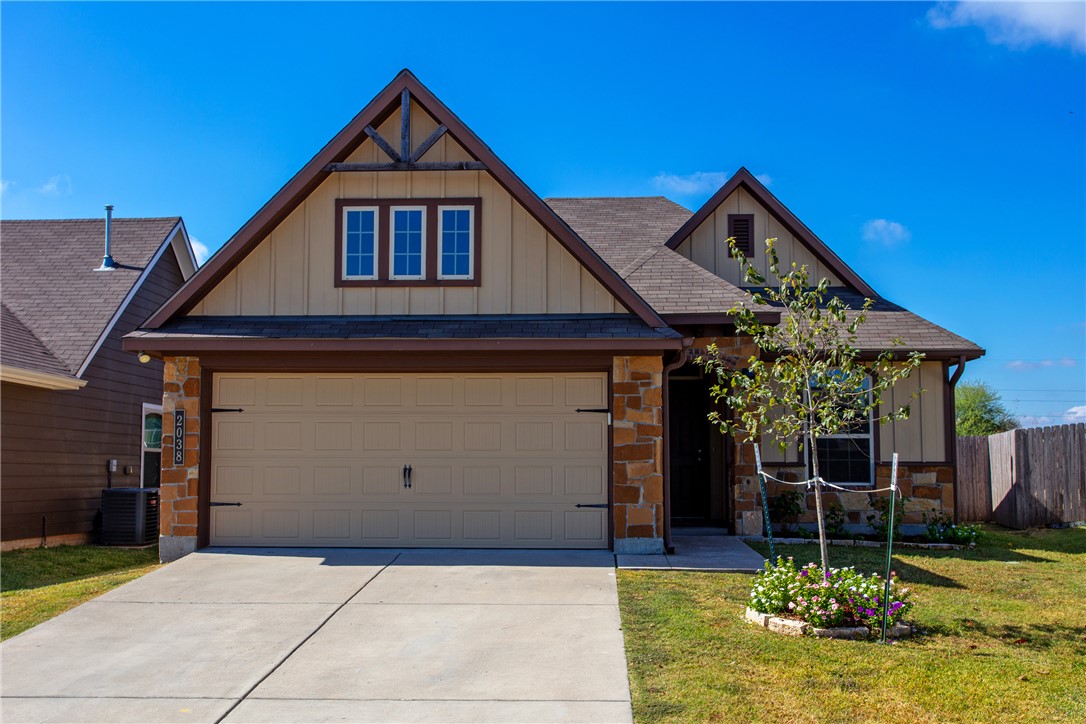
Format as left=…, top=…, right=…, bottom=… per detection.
left=927, top=1, right=1086, bottom=52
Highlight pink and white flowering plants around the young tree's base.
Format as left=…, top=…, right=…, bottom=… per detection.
left=749, top=557, right=912, bottom=628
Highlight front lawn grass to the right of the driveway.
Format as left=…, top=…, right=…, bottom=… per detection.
left=618, top=526, right=1086, bottom=722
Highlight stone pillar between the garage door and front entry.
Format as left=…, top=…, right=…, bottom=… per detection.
left=611, top=357, right=664, bottom=554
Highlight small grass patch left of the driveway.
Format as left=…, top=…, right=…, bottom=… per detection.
left=0, top=546, right=159, bottom=640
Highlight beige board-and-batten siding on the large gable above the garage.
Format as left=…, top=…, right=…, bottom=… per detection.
left=189, top=103, right=623, bottom=316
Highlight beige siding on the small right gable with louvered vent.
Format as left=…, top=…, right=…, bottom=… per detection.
left=675, top=187, right=845, bottom=287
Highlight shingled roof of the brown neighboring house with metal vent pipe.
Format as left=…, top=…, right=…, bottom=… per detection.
left=0, top=216, right=194, bottom=379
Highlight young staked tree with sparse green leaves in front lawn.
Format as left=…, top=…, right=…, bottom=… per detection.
left=700, top=239, right=922, bottom=574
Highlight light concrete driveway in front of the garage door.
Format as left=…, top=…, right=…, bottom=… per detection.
left=0, top=548, right=631, bottom=723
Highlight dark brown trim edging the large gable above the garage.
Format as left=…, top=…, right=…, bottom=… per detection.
left=146, top=69, right=665, bottom=329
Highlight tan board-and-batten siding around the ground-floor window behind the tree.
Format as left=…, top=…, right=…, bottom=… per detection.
left=761, top=361, right=947, bottom=465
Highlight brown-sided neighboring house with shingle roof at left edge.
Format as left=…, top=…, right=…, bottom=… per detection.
left=0, top=217, right=195, bottom=549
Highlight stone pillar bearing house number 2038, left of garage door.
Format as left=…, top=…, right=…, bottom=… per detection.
left=159, top=357, right=200, bottom=562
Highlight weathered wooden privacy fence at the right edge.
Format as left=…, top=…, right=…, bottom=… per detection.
left=957, top=423, right=1086, bottom=529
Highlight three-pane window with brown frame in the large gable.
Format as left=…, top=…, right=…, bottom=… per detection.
left=334, top=199, right=482, bottom=287
